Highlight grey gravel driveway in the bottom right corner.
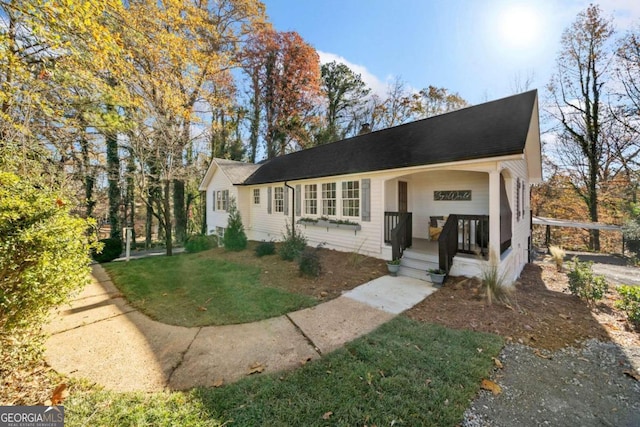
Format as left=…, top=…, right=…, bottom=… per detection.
left=462, top=340, right=640, bottom=427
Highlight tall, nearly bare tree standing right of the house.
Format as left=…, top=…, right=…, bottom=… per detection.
left=548, top=5, right=613, bottom=251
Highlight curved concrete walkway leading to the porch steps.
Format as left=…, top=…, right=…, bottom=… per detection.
left=46, top=265, right=436, bottom=391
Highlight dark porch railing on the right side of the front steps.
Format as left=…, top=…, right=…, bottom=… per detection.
left=438, top=214, right=489, bottom=273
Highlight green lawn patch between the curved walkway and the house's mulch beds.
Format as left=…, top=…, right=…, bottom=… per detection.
left=103, top=251, right=317, bottom=327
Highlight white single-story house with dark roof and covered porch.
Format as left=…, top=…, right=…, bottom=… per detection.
left=200, top=90, right=542, bottom=280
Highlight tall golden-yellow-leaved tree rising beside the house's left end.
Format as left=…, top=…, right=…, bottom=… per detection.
left=112, top=0, right=264, bottom=255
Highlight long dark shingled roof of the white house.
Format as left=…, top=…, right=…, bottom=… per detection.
left=244, top=90, right=537, bottom=184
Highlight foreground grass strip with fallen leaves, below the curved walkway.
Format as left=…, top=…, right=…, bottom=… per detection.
left=65, top=317, right=503, bottom=426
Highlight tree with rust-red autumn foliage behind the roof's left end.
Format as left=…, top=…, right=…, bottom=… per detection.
left=243, top=28, right=320, bottom=160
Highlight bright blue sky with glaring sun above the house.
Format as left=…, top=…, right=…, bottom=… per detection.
left=264, top=0, right=640, bottom=104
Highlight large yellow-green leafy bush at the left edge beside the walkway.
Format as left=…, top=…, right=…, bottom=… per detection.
left=0, top=172, right=91, bottom=378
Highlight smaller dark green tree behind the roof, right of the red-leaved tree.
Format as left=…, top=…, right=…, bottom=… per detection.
left=318, top=61, right=371, bottom=143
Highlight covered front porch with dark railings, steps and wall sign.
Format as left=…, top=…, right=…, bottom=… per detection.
left=384, top=170, right=511, bottom=277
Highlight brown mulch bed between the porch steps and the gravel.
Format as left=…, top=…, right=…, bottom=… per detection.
left=406, top=263, right=640, bottom=350
